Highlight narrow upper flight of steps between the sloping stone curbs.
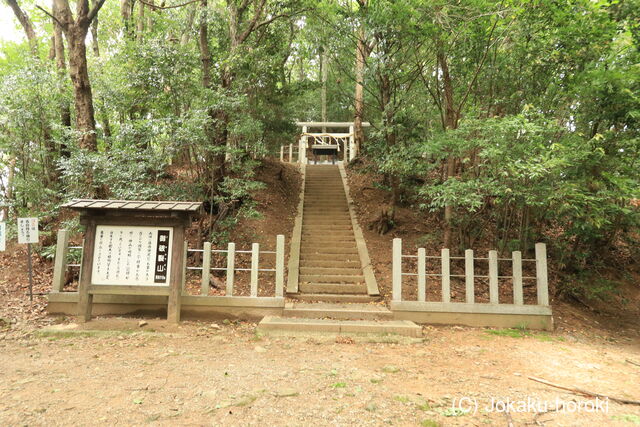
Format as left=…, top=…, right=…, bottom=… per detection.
left=291, top=165, right=374, bottom=303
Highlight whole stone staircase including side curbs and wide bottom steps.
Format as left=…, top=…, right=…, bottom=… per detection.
left=258, top=165, right=422, bottom=337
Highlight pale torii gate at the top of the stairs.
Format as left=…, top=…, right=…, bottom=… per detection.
left=296, top=122, right=370, bottom=164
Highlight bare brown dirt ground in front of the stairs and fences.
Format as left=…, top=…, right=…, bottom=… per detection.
left=0, top=318, right=640, bottom=426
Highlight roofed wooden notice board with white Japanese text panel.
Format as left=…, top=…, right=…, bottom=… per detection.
left=63, top=200, right=202, bottom=323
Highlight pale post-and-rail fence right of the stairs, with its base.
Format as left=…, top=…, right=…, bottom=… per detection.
left=392, top=239, right=550, bottom=314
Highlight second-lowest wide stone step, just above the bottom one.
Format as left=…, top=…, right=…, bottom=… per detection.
left=283, top=302, right=393, bottom=320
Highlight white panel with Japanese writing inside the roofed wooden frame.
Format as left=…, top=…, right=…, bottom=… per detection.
left=91, top=225, right=173, bottom=286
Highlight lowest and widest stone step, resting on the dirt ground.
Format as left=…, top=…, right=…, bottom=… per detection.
left=257, top=316, right=422, bottom=338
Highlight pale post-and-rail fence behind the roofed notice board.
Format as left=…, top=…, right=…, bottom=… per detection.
left=52, top=230, right=285, bottom=298
